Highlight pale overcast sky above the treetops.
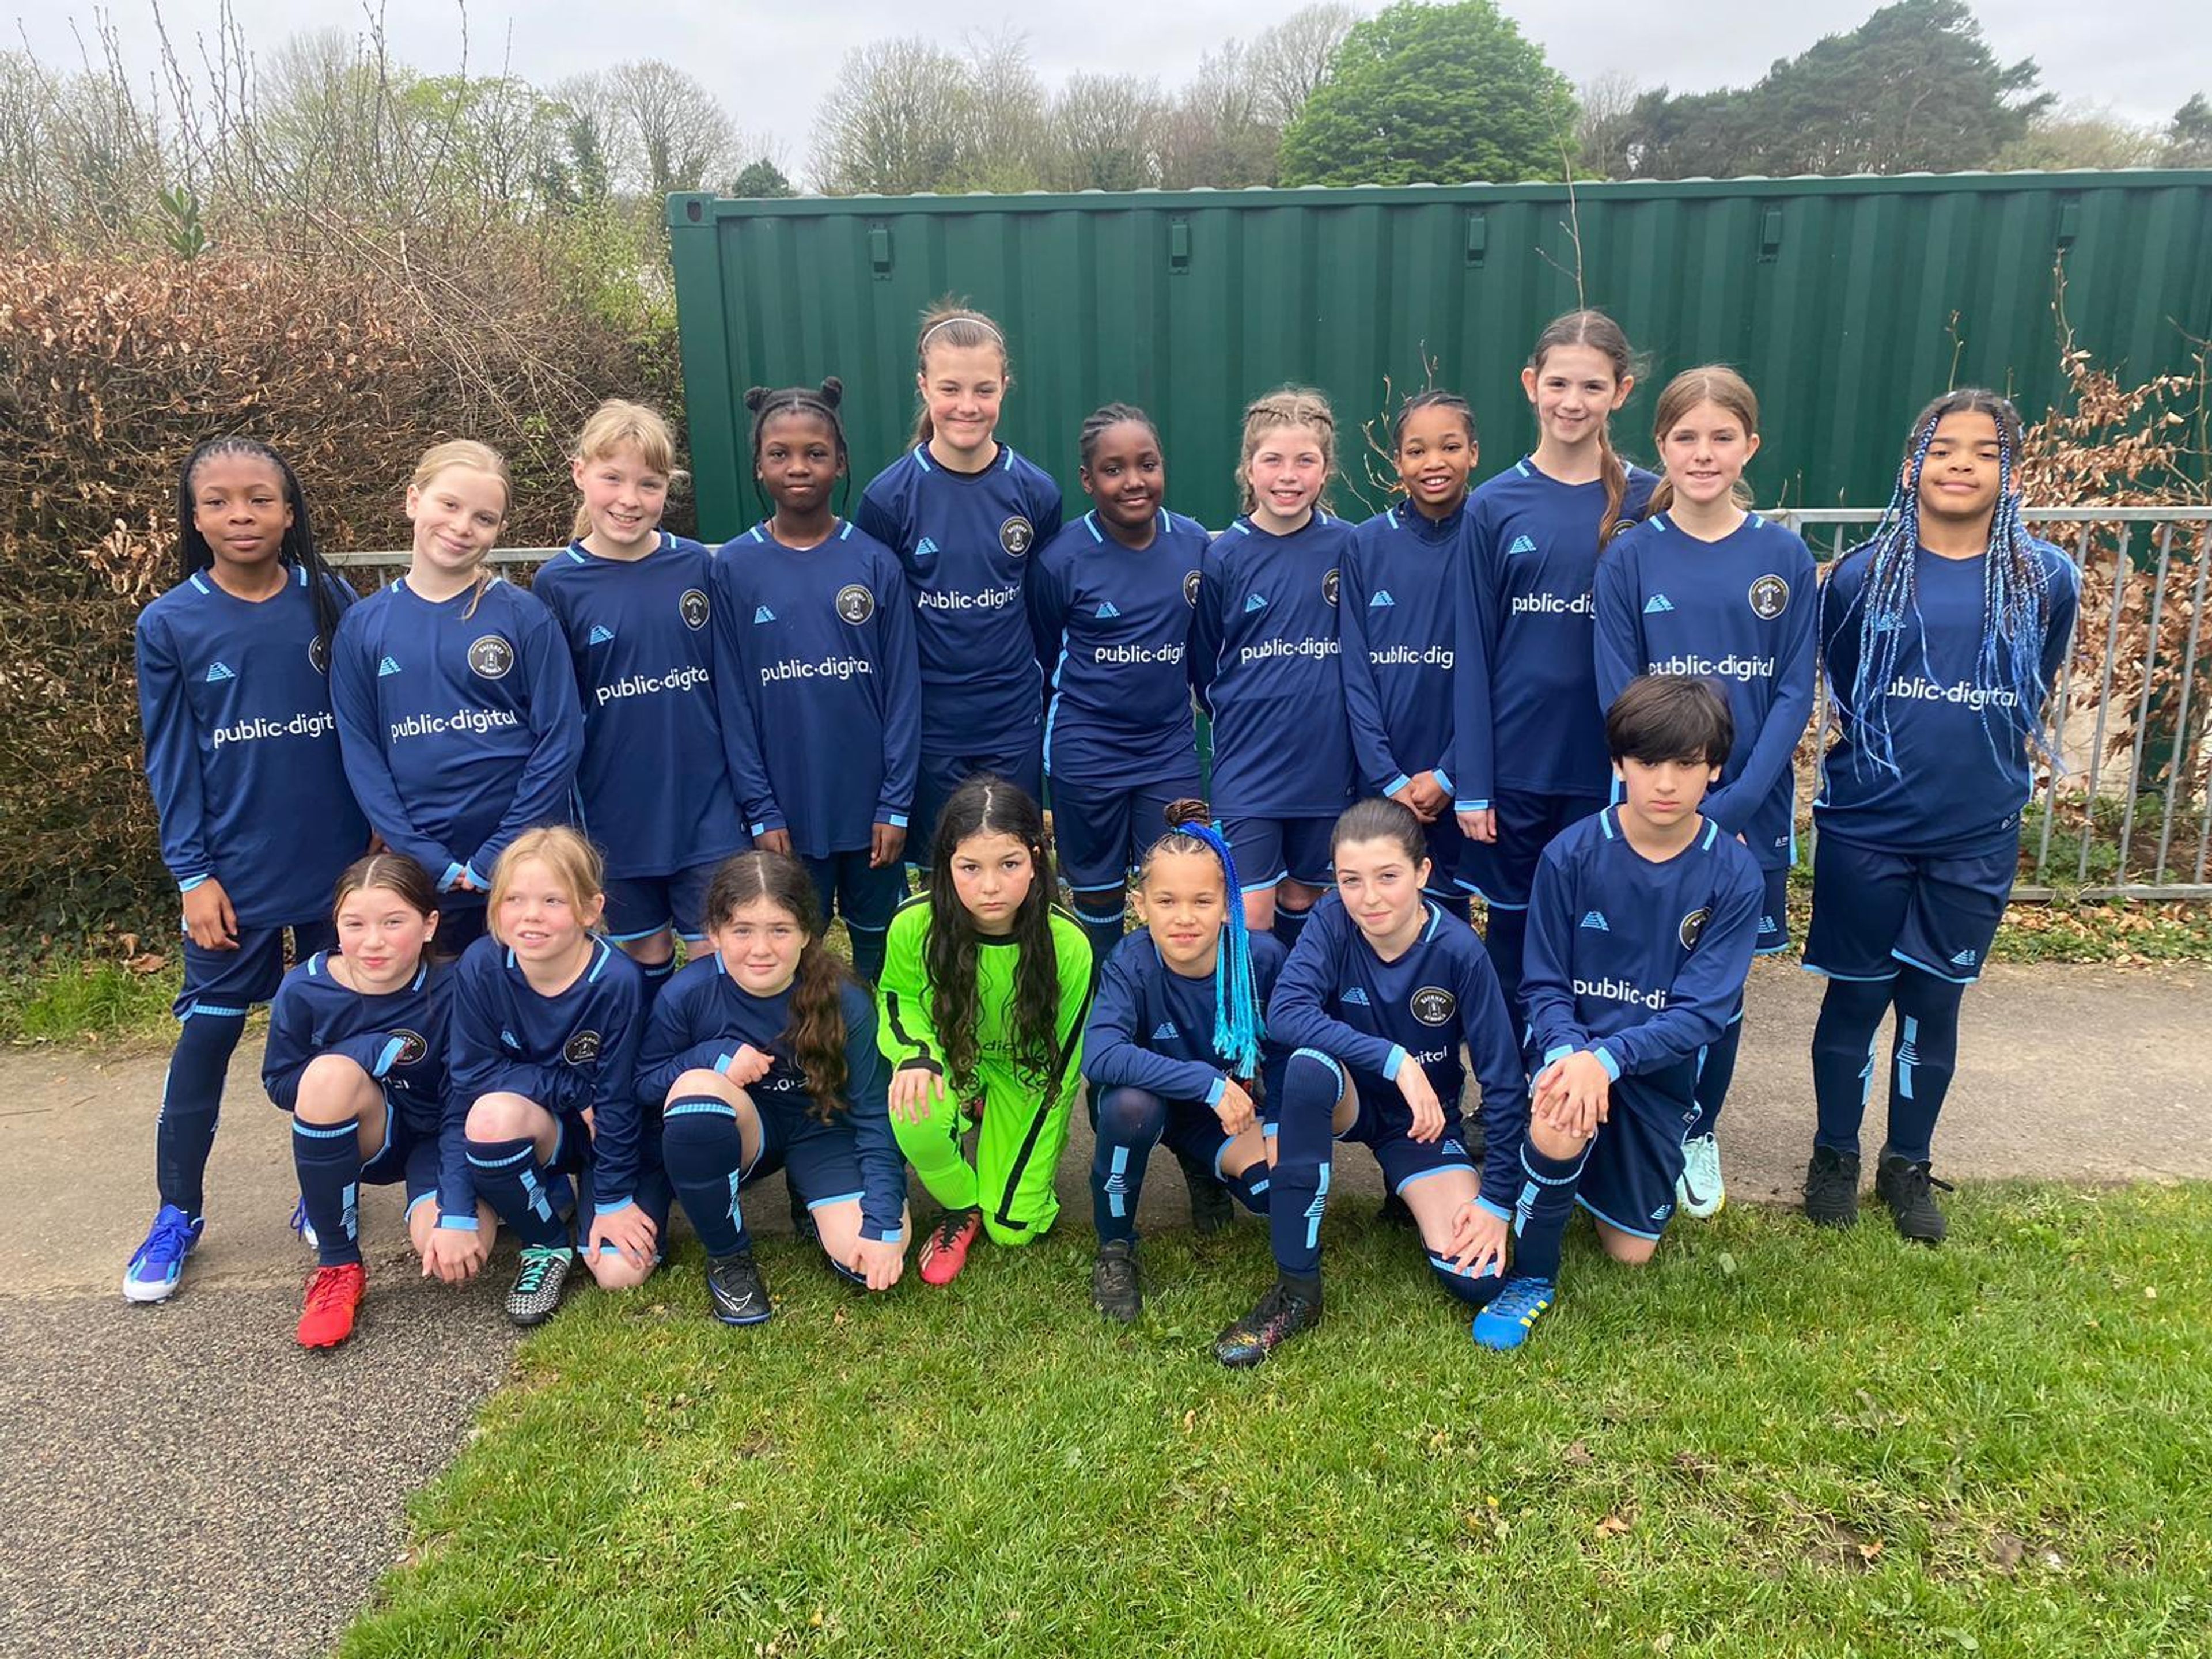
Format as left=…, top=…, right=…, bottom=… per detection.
left=0, top=0, right=2212, bottom=171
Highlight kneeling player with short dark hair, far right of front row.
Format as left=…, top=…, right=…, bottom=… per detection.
left=1473, top=675, right=1765, bottom=1347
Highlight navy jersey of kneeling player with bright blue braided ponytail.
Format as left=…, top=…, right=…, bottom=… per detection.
left=1084, top=929, right=1290, bottom=1106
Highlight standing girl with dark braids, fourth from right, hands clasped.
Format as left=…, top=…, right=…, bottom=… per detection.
left=1338, top=392, right=1475, bottom=911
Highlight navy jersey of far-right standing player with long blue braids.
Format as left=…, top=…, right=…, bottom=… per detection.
left=1812, top=542, right=2081, bottom=858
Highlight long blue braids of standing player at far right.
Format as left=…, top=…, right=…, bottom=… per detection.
left=1845, top=387, right=2051, bottom=774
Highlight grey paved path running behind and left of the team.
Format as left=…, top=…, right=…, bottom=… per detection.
left=0, top=964, right=2212, bottom=1659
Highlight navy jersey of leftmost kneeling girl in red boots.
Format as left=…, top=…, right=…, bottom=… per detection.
left=261, top=951, right=476, bottom=1228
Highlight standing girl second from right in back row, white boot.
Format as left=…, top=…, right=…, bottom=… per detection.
left=1597, top=365, right=1818, bottom=1219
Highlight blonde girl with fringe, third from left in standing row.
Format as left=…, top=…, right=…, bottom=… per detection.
left=531, top=400, right=745, bottom=998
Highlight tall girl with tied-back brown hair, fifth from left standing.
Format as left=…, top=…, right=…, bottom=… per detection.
left=854, top=305, right=1059, bottom=854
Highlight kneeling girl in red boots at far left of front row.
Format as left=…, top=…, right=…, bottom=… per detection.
left=261, top=851, right=498, bottom=1347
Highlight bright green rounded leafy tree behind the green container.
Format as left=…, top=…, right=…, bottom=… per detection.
left=1281, top=0, right=1575, bottom=184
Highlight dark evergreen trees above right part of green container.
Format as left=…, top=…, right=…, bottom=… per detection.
left=1622, top=0, right=2053, bottom=179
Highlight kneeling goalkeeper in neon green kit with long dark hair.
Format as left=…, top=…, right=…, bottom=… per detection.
left=876, top=774, right=1090, bottom=1285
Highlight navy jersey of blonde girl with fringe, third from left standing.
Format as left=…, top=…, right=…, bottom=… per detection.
left=531, top=531, right=745, bottom=876
